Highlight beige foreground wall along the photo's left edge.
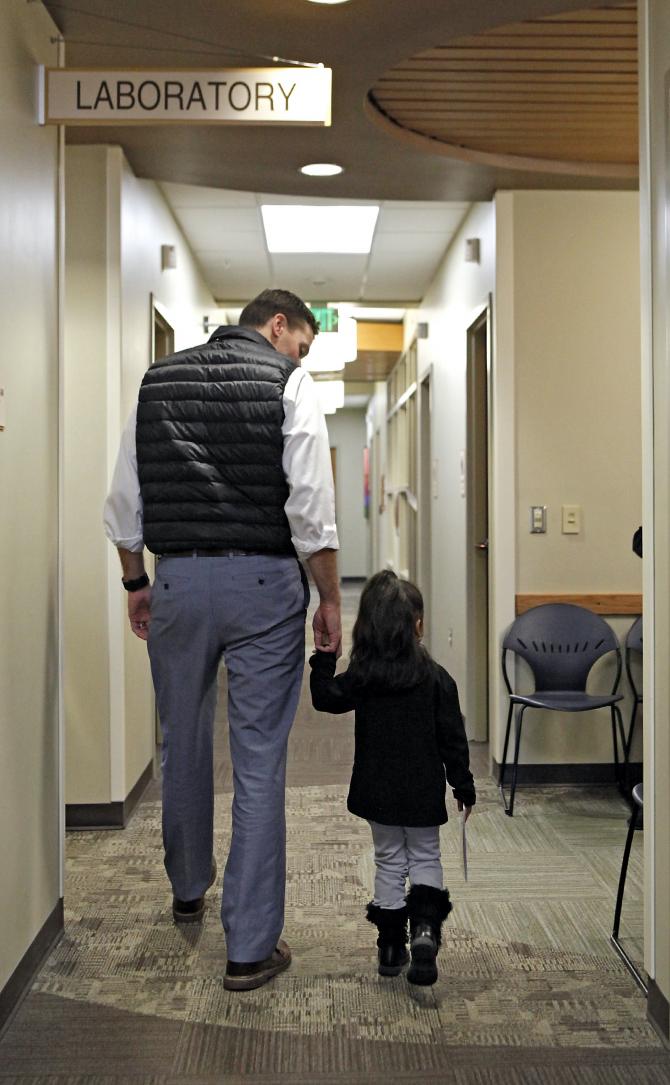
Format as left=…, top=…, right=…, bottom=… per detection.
left=0, top=0, right=61, bottom=990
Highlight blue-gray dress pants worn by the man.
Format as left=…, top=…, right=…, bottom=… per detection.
left=149, top=554, right=309, bottom=961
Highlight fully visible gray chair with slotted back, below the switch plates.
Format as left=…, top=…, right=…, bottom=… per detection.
left=500, top=603, right=627, bottom=817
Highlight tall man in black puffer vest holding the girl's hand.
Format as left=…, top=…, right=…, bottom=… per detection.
left=105, top=290, right=340, bottom=991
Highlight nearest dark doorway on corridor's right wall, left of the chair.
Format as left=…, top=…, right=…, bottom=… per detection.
left=464, top=305, right=491, bottom=742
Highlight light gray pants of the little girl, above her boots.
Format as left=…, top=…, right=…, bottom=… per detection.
left=369, top=821, right=442, bottom=909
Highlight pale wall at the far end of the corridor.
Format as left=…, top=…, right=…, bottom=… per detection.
left=325, top=408, right=370, bottom=577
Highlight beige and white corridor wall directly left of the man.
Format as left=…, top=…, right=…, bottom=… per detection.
left=65, top=146, right=214, bottom=803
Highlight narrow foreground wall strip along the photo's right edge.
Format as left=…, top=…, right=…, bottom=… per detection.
left=640, top=0, right=670, bottom=1042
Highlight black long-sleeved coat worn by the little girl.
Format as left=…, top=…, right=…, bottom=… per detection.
left=309, top=652, right=475, bottom=827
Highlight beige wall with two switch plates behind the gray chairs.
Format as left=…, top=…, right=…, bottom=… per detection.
left=493, top=192, right=642, bottom=764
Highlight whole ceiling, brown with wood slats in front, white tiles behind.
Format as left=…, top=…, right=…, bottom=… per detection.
left=43, top=0, right=637, bottom=302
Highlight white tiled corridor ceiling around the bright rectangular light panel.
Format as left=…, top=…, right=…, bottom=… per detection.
left=160, top=183, right=469, bottom=303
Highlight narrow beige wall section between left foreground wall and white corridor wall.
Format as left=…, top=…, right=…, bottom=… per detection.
left=63, top=146, right=119, bottom=803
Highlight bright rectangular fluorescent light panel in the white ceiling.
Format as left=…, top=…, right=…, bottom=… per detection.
left=260, top=204, right=379, bottom=253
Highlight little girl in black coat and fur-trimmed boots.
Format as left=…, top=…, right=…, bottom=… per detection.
left=309, top=571, right=475, bottom=985
